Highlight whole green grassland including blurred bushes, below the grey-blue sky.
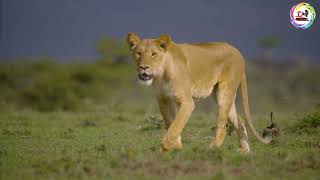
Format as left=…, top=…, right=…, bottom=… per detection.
left=0, top=60, right=320, bottom=179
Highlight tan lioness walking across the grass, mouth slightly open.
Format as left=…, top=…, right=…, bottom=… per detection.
left=126, top=33, right=271, bottom=153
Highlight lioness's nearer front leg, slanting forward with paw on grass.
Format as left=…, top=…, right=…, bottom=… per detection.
left=161, top=97, right=194, bottom=151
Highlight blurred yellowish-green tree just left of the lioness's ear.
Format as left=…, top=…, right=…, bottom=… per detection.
left=96, top=37, right=129, bottom=63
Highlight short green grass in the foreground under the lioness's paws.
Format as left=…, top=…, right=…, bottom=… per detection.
left=0, top=103, right=320, bottom=179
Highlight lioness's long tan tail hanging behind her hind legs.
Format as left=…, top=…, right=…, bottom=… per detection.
left=240, top=75, right=272, bottom=144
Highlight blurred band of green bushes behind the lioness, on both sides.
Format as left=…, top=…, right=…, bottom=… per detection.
left=0, top=57, right=320, bottom=113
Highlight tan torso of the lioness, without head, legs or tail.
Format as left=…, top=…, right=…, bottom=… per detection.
left=164, top=43, right=244, bottom=98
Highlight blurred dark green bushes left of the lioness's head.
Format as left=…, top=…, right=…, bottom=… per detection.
left=0, top=60, right=134, bottom=111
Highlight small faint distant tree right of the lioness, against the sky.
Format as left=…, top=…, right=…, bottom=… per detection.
left=258, top=36, right=280, bottom=60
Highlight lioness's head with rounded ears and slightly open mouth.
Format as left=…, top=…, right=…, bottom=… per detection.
left=127, top=33, right=171, bottom=85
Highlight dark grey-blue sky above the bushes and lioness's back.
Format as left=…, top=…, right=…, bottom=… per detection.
left=0, top=0, right=320, bottom=61
